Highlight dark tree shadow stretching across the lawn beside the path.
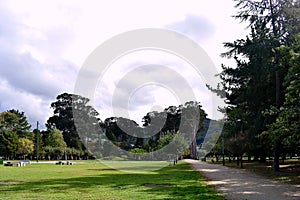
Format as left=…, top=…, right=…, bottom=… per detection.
left=0, top=164, right=222, bottom=199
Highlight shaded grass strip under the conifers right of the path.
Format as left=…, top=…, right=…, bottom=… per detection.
left=207, top=159, right=300, bottom=185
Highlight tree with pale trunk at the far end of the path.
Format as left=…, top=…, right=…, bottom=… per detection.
left=143, top=101, right=206, bottom=159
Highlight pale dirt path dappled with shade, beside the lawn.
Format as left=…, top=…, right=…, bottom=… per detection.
left=185, top=160, right=300, bottom=200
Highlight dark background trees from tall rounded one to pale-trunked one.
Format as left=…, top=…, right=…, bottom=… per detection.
left=46, top=93, right=206, bottom=159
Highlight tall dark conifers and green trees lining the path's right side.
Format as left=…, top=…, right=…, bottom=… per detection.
left=210, top=0, right=300, bottom=171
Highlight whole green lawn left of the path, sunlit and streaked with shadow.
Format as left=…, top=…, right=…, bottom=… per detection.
left=0, top=162, right=223, bottom=200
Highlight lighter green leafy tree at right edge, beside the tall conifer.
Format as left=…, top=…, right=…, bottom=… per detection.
left=263, top=34, right=300, bottom=162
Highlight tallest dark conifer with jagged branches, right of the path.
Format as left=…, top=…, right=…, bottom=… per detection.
left=211, top=0, right=299, bottom=170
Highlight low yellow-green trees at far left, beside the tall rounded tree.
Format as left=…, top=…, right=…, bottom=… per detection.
left=0, top=110, right=87, bottom=159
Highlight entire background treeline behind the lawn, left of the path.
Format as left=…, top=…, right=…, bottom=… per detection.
left=0, top=93, right=206, bottom=160
